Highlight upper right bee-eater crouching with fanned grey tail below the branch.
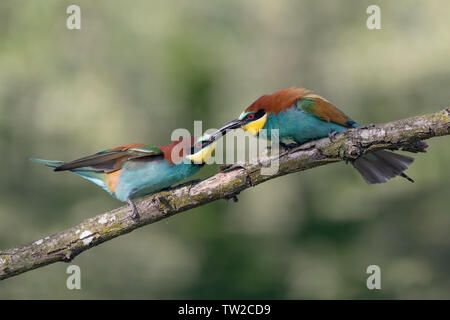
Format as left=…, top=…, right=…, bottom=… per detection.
left=213, top=87, right=414, bottom=184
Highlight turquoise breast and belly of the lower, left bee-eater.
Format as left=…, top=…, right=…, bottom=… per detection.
left=114, top=158, right=202, bottom=201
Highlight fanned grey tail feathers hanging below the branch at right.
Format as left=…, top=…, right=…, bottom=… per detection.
left=353, top=150, right=414, bottom=184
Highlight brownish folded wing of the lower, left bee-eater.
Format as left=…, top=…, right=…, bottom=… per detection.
left=55, top=143, right=162, bottom=173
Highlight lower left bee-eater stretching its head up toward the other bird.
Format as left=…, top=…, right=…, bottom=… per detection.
left=30, top=136, right=215, bottom=218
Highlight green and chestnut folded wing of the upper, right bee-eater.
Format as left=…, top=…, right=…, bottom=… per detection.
left=297, top=94, right=356, bottom=128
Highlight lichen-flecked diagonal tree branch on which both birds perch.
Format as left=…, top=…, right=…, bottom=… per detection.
left=0, top=108, right=450, bottom=280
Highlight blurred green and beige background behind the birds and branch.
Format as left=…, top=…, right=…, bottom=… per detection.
left=0, top=0, right=450, bottom=299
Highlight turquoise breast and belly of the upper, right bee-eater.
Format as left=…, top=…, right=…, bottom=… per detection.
left=264, top=108, right=357, bottom=143
